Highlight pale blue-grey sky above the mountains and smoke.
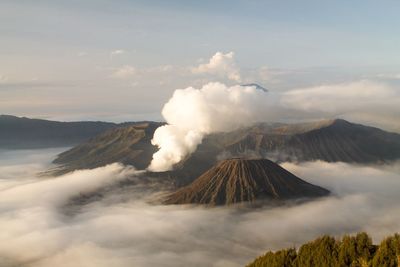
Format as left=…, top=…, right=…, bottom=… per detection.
left=0, top=0, right=400, bottom=125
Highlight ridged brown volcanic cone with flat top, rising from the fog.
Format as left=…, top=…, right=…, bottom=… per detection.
left=164, top=158, right=329, bottom=206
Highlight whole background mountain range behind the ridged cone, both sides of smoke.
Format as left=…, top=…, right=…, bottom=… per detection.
left=0, top=115, right=400, bottom=186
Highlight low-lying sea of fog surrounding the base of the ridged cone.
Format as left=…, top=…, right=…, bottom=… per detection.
left=0, top=149, right=400, bottom=267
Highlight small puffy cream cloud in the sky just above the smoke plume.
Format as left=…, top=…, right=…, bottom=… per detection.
left=192, top=52, right=241, bottom=82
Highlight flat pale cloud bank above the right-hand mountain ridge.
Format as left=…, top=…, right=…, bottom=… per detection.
left=280, top=80, right=400, bottom=132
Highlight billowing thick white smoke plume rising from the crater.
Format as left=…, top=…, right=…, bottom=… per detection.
left=149, top=83, right=271, bottom=171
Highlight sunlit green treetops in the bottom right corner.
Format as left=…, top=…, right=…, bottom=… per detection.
left=247, top=233, right=400, bottom=267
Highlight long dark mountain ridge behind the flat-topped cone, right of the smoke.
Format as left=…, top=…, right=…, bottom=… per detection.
left=170, top=119, right=400, bottom=186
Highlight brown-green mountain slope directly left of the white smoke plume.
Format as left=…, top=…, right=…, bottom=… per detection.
left=53, top=122, right=162, bottom=174
